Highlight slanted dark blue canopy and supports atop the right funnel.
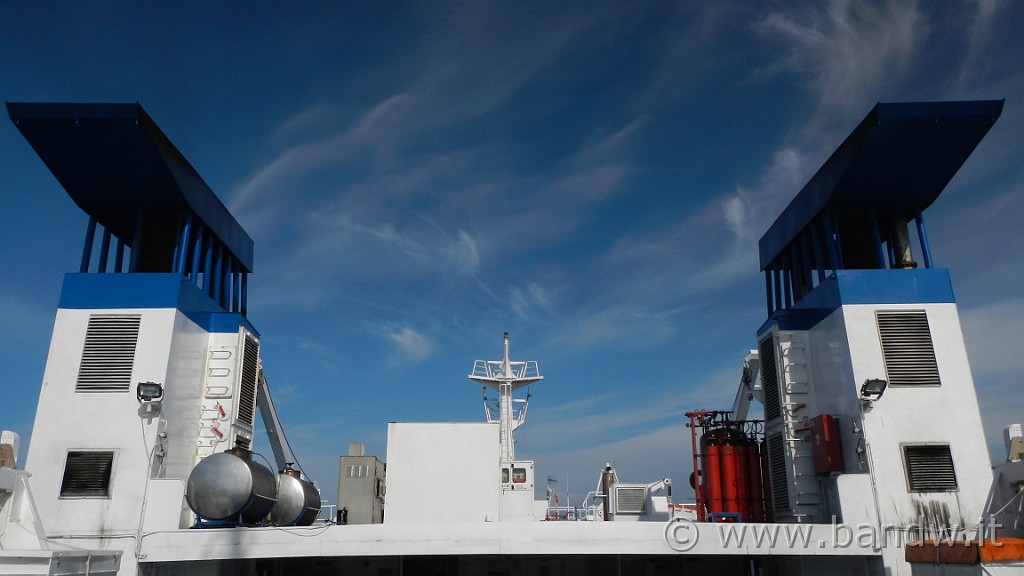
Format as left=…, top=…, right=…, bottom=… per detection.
left=759, top=100, right=1002, bottom=315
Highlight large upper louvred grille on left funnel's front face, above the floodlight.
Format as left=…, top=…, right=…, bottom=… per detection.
left=75, top=315, right=141, bottom=393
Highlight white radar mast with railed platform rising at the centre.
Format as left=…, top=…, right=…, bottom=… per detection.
left=468, top=332, right=544, bottom=462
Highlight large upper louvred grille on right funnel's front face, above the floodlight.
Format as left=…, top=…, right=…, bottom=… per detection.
left=876, top=311, right=941, bottom=386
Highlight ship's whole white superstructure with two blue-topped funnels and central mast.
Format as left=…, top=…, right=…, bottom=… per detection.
left=0, top=101, right=1024, bottom=576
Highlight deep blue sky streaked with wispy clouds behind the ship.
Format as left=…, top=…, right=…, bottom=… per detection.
left=0, top=0, right=1024, bottom=502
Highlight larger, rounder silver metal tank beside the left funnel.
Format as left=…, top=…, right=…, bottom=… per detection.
left=185, top=448, right=278, bottom=524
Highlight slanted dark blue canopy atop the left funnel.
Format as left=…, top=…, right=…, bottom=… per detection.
left=7, top=102, right=253, bottom=272
